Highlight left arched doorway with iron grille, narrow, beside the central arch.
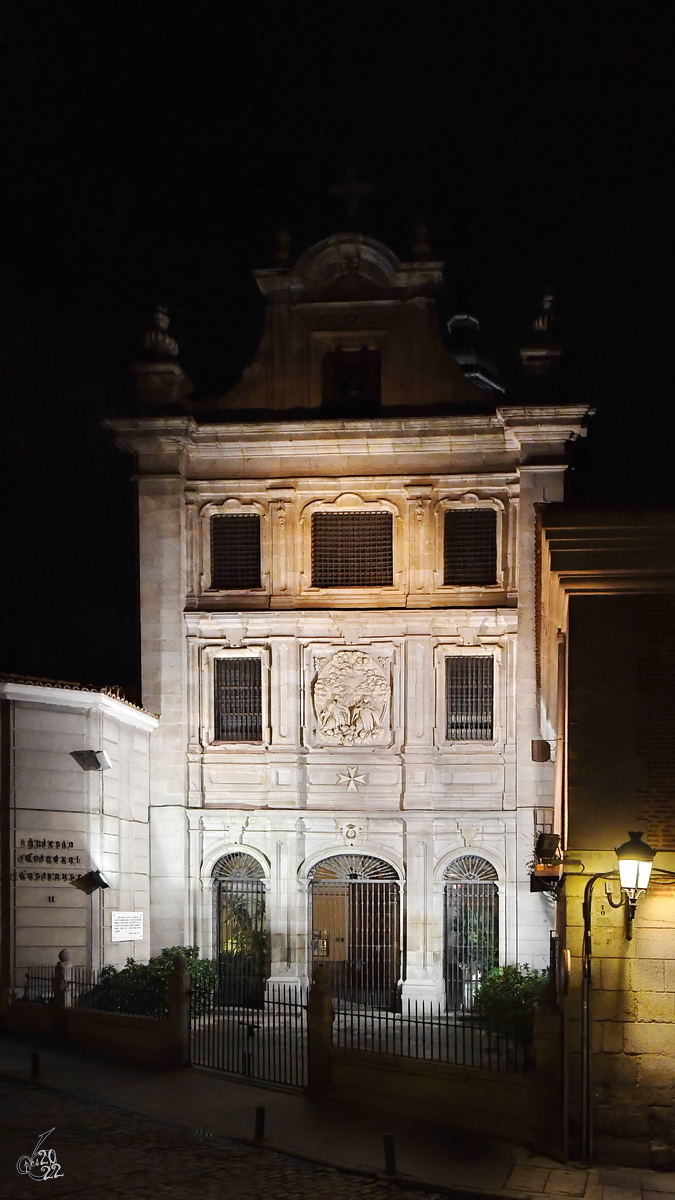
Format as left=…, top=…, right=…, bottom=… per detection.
left=214, top=853, right=268, bottom=1006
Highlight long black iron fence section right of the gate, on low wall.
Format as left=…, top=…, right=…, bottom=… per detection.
left=333, top=1001, right=533, bottom=1072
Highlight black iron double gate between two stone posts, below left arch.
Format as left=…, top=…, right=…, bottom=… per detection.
left=190, top=965, right=307, bottom=1087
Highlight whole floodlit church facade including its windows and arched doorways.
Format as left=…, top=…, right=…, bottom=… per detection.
left=109, top=234, right=587, bottom=1004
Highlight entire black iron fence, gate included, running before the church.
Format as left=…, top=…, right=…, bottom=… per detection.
left=24, top=962, right=533, bottom=1087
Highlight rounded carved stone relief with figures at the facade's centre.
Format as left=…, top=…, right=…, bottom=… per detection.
left=312, top=650, right=390, bottom=746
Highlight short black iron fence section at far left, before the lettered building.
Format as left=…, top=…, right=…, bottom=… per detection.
left=24, top=964, right=167, bottom=1019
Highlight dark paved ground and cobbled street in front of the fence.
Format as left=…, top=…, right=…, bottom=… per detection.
left=0, top=1033, right=675, bottom=1200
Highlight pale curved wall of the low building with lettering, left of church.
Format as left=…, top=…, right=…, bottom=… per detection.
left=0, top=679, right=157, bottom=988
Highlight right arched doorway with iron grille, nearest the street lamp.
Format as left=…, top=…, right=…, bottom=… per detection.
left=444, top=854, right=500, bottom=1010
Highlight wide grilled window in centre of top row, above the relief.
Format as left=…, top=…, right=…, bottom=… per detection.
left=312, top=512, right=394, bottom=588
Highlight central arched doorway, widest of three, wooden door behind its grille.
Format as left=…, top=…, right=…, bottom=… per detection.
left=310, top=854, right=400, bottom=1008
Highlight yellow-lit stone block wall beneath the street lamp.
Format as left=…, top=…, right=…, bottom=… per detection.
left=565, top=851, right=675, bottom=1166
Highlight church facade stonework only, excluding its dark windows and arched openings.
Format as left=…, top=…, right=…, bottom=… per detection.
left=109, top=235, right=586, bottom=1000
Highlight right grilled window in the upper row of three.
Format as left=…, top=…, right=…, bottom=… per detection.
left=443, top=509, right=497, bottom=588
